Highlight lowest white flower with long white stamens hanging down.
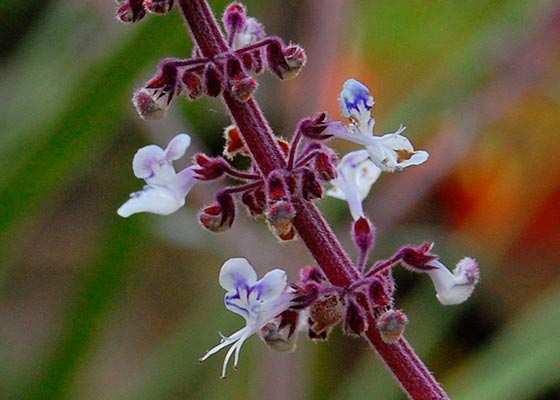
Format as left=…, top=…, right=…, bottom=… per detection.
left=200, top=258, right=294, bottom=378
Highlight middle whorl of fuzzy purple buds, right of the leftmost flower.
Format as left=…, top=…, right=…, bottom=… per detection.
left=194, top=126, right=337, bottom=241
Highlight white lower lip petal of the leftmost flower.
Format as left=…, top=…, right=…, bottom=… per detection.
left=117, top=185, right=185, bottom=218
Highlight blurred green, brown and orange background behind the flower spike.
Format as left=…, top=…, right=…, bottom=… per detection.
left=0, top=0, right=560, bottom=400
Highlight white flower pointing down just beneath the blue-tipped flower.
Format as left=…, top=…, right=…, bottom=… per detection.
left=327, top=150, right=381, bottom=221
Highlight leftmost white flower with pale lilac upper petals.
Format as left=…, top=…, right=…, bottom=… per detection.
left=117, top=133, right=196, bottom=217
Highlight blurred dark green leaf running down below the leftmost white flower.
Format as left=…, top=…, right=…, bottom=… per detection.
left=18, top=215, right=149, bottom=399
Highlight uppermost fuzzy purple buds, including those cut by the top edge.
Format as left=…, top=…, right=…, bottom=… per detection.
left=129, top=0, right=307, bottom=119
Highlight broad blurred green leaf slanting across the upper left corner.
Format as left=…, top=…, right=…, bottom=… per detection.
left=0, top=9, right=188, bottom=282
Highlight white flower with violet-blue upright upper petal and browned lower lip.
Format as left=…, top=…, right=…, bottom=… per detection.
left=327, top=79, right=428, bottom=172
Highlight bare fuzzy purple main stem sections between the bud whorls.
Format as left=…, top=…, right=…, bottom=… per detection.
left=179, top=0, right=448, bottom=400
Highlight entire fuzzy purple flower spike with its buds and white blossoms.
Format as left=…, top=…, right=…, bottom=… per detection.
left=117, top=0, right=479, bottom=399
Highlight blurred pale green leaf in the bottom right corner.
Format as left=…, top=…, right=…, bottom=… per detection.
left=444, top=284, right=560, bottom=400
